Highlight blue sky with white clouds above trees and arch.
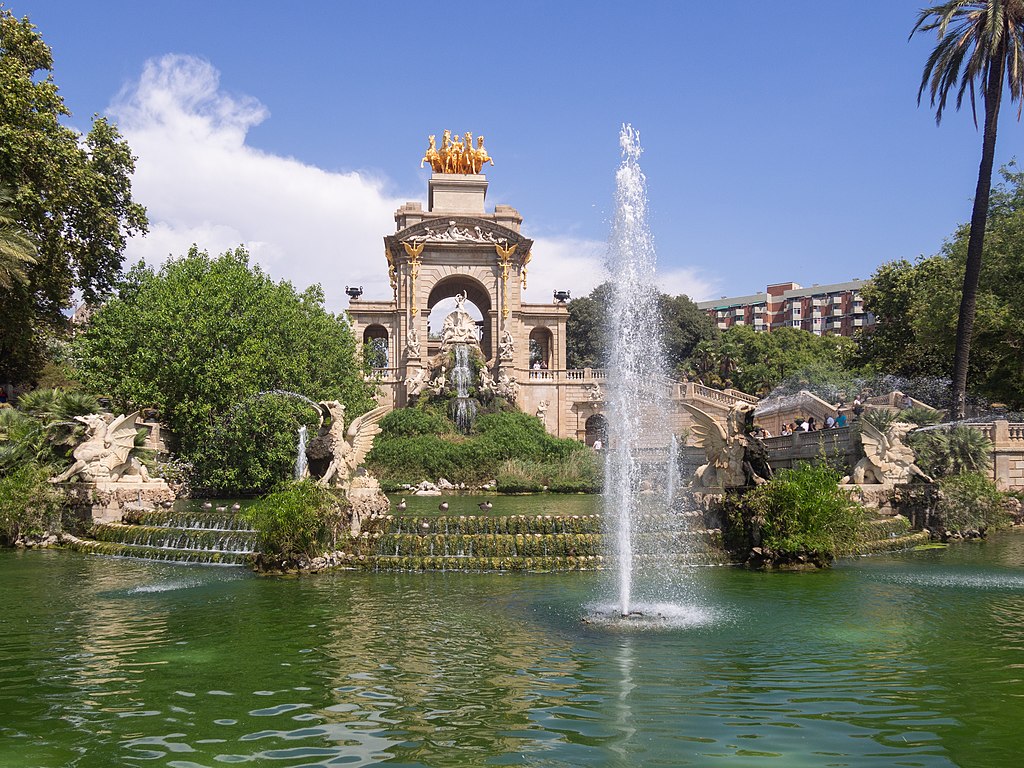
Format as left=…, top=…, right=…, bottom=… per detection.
left=6, top=0, right=1021, bottom=308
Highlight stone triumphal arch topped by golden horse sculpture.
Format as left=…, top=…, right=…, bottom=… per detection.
left=348, top=132, right=753, bottom=441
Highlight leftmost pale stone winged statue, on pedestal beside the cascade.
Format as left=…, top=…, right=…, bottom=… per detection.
left=50, top=411, right=150, bottom=482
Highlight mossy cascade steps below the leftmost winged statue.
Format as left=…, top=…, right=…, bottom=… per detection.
left=69, top=510, right=256, bottom=565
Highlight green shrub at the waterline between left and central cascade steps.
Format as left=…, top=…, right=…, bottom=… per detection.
left=242, top=480, right=345, bottom=559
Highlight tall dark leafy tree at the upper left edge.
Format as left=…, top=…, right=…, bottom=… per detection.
left=0, top=7, right=147, bottom=381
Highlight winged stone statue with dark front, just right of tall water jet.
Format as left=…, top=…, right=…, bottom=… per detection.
left=682, top=402, right=771, bottom=488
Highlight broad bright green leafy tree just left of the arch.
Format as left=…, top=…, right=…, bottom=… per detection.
left=74, top=247, right=373, bottom=493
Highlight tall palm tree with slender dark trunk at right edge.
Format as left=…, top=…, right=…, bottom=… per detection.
left=910, top=0, right=1024, bottom=419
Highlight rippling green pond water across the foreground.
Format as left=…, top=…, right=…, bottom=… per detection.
left=0, top=534, right=1024, bottom=768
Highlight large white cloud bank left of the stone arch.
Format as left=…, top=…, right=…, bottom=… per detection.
left=110, top=54, right=403, bottom=311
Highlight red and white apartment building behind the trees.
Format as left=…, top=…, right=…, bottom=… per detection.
left=697, top=280, right=874, bottom=336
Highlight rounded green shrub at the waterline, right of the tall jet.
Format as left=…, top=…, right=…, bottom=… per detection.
left=727, top=464, right=862, bottom=564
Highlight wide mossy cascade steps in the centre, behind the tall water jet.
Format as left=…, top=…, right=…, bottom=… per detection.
left=331, top=513, right=727, bottom=570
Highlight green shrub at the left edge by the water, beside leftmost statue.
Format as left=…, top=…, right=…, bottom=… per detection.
left=0, top=462, right=60, bottom=545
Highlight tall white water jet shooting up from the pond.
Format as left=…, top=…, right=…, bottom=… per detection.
left=604, top=125, right=678, bottom=616
